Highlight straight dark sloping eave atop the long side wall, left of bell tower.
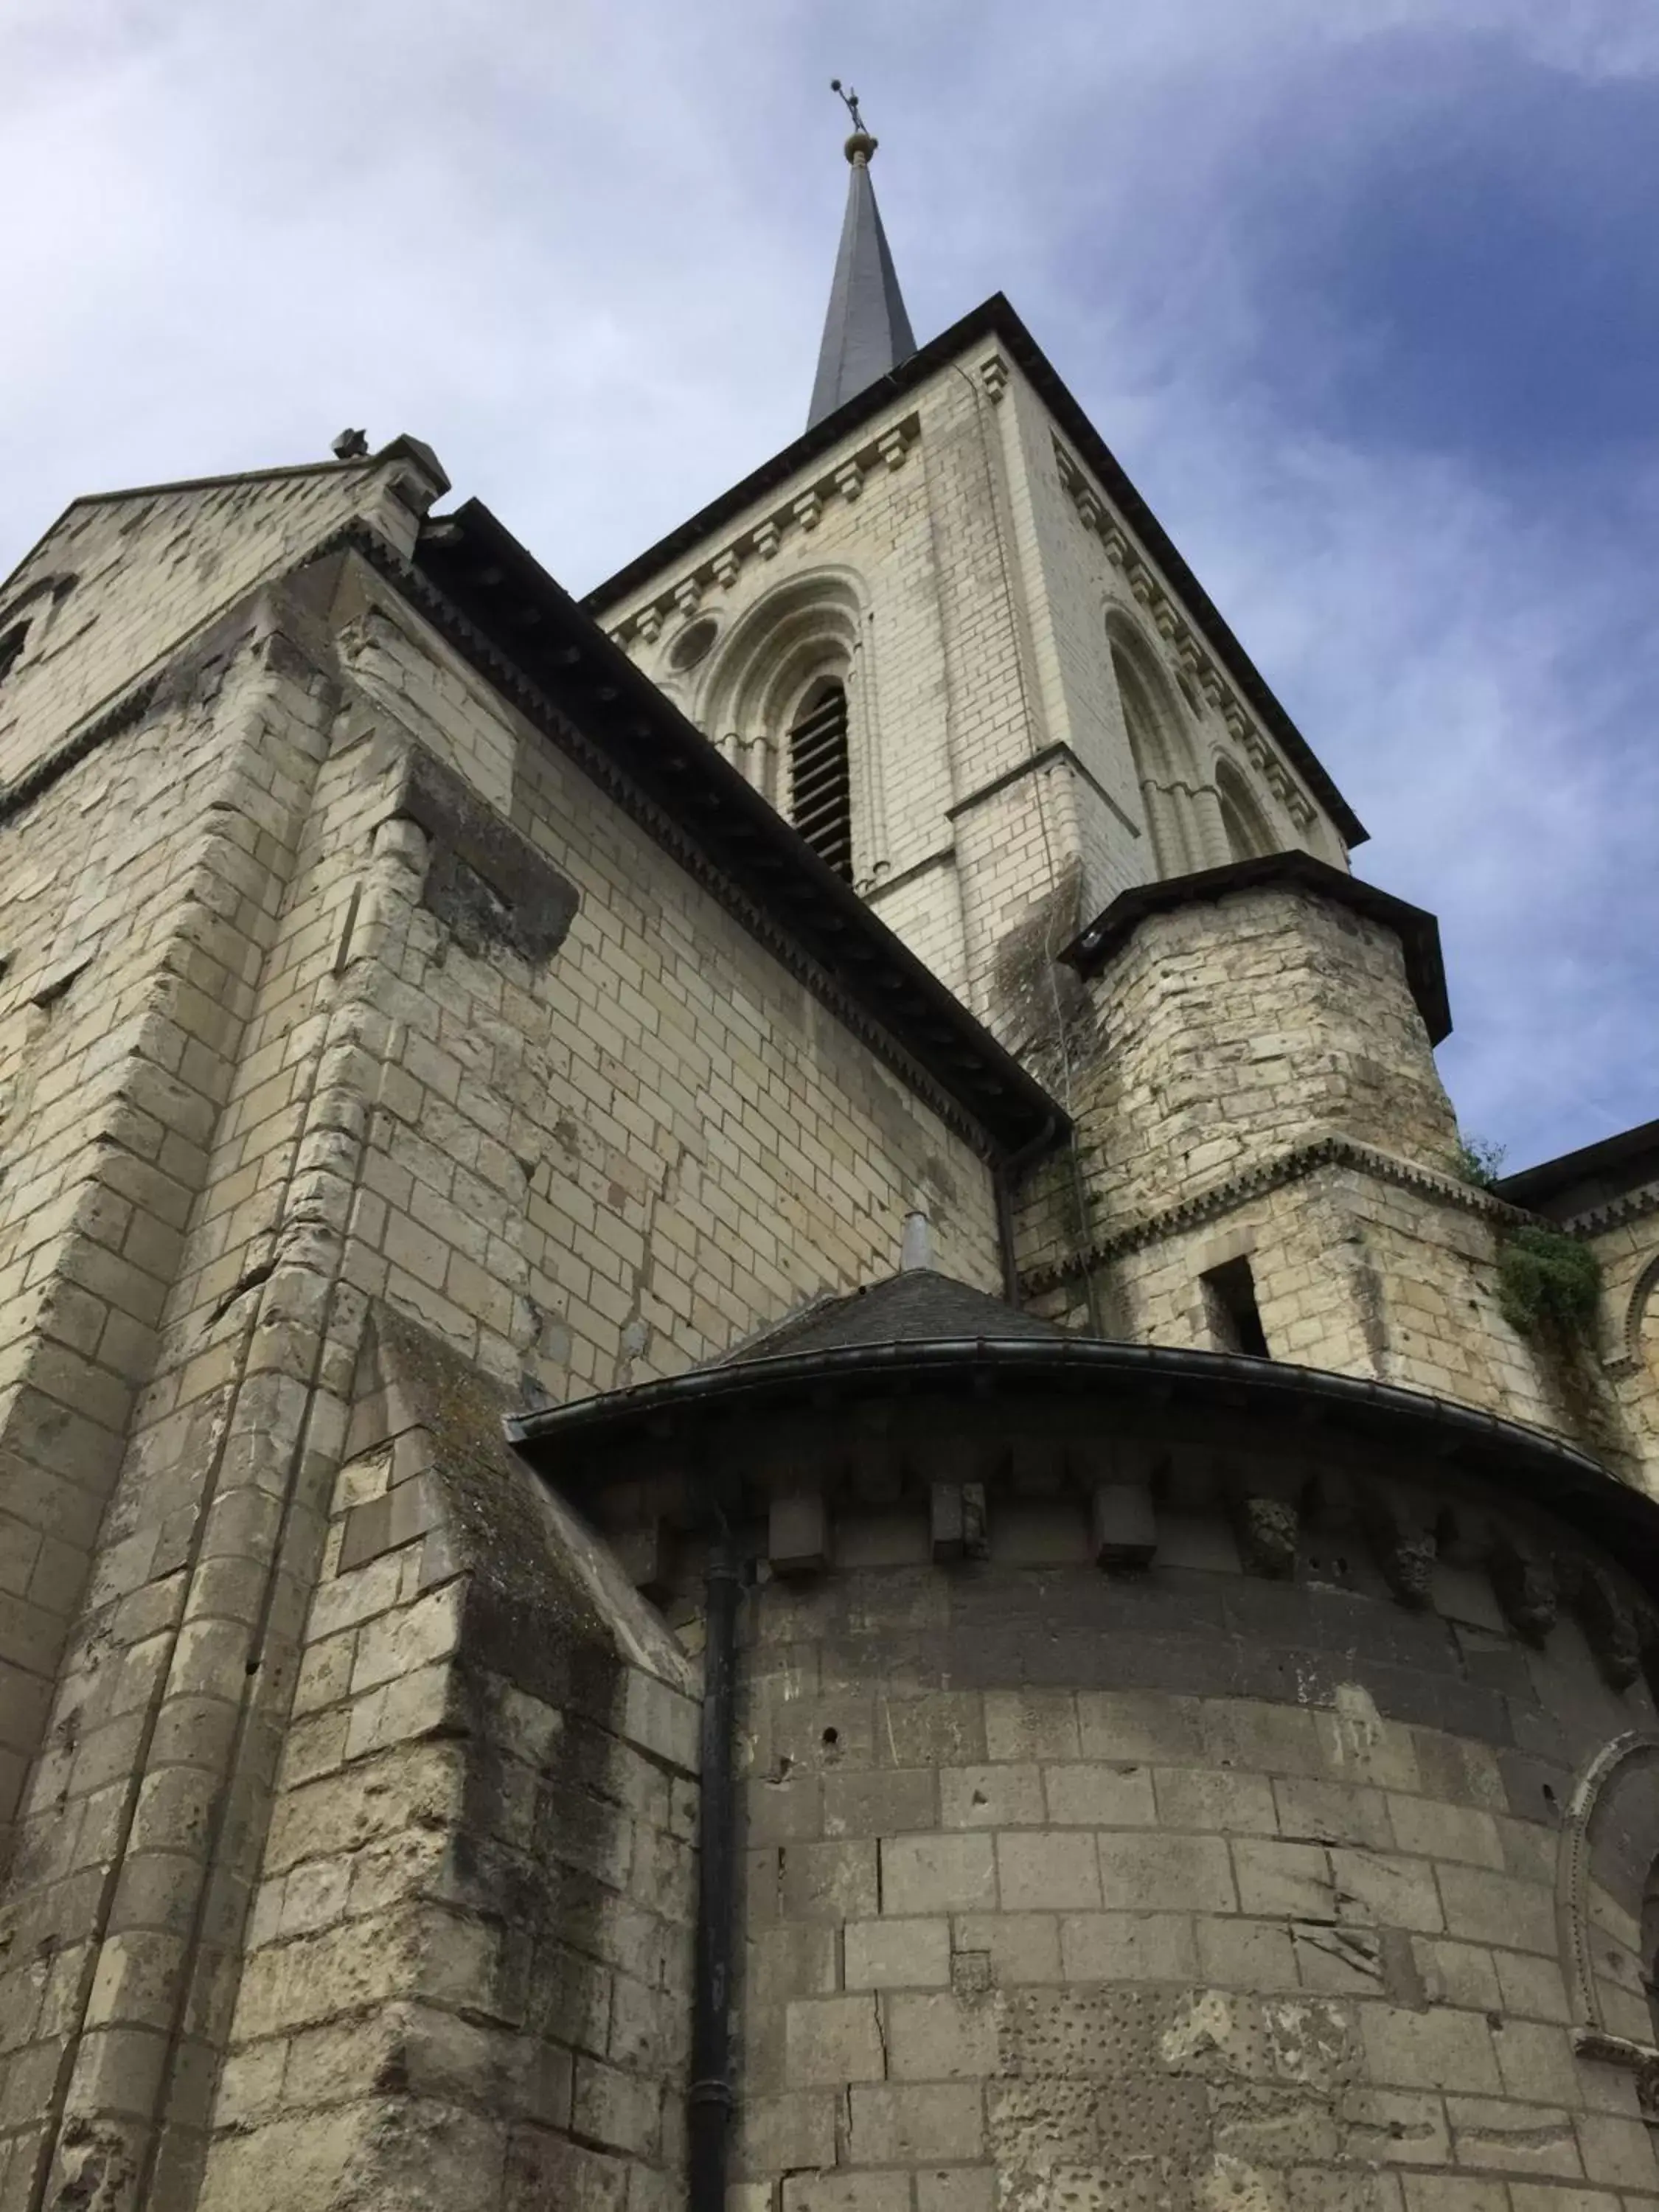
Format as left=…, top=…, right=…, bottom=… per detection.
left=389, top=500, right=1071, bottom=1159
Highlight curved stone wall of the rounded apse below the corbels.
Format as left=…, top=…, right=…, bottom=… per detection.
left=737, top=1462, right=1659, bottom=2212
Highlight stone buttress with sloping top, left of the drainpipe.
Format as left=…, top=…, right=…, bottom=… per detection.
left=195, top=1318, right=699, bottom=2212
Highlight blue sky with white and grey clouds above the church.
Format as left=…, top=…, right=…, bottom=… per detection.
left=0, top=0, right=1659, bottom=1168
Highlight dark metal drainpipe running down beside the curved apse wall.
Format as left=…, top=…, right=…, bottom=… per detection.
left=686, top=1524, right=741, bottom=2212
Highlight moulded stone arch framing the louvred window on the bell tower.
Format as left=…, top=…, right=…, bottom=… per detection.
left=695, top=568, right=885, bottom=880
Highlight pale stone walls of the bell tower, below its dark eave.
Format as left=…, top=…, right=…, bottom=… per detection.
left=602, top=345, right=1345, bottom=1040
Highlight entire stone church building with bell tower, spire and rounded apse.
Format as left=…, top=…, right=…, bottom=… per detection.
left=0, top=111, right=1659, bottom=2212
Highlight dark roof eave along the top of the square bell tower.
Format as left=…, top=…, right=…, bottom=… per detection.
left=582, top=292, right=1369, bottom=845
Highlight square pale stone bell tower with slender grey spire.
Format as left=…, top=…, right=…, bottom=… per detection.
left=586, top=100, right=1365, bottom=1044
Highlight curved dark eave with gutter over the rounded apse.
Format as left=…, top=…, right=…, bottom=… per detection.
left=502, top=1336, right=1659, bottom=1595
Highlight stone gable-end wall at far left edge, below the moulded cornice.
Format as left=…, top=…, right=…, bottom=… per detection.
left=0, top=580, right=345, bottom=1867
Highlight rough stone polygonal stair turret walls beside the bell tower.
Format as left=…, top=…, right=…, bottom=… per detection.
left=1022, top=889, right=1637, bottom=1478
